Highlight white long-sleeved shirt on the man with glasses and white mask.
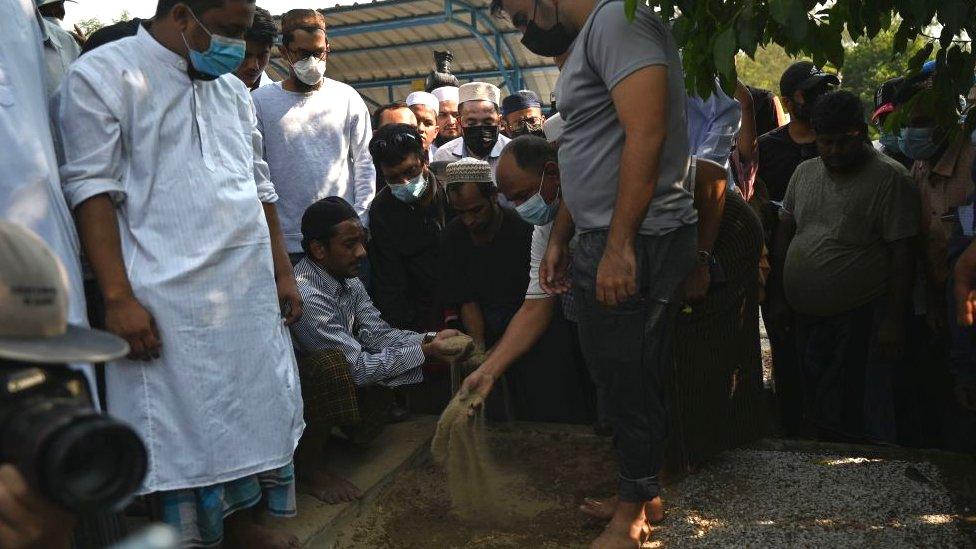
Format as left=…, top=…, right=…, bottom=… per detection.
left=251, top=78, right=376, bottom=253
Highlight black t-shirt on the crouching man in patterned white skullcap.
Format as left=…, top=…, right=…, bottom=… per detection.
left=440, top=208, right=533, bottom=307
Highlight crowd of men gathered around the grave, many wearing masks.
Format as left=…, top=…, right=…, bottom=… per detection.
left=0, top=0, right=976, bottom=548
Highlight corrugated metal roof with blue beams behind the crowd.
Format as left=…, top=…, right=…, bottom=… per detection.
left=294, top=0, right=558, bottom=107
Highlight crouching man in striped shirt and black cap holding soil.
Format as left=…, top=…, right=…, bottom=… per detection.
left=291, top=196, right=460, bottom=503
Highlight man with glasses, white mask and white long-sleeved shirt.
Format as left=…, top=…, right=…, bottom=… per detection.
left=254, top=9, right=376, bottom=261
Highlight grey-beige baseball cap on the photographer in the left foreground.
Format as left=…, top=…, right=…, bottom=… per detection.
left=0, top=221, right=129, bottom=363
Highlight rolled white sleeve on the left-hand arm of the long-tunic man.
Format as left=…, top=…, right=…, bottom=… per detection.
left=54, top=63, right=126, bottom=209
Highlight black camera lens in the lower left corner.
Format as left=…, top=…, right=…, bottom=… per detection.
left=0, top=398, right=147, bottom=512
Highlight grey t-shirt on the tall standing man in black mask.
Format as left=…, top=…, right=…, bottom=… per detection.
left=556, top=0, right=697, bottom=235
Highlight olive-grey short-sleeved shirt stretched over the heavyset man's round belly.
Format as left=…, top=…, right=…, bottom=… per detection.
left=783, top=150, right=920, bottom=316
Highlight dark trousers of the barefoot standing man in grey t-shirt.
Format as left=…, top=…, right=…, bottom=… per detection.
left=573, top=225, right=697, bottom=502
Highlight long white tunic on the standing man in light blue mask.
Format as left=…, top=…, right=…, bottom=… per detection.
left=57, top=28, right=304, bottom=493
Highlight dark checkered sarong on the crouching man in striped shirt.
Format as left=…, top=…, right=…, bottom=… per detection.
left=298, top=349, right=360, bottom=428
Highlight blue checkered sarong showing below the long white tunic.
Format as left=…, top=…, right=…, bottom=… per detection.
left=154, top=463, right=297, bottom=547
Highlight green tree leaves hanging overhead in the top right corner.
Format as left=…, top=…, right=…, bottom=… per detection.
left=626, top=0, right=976, bottom=130
